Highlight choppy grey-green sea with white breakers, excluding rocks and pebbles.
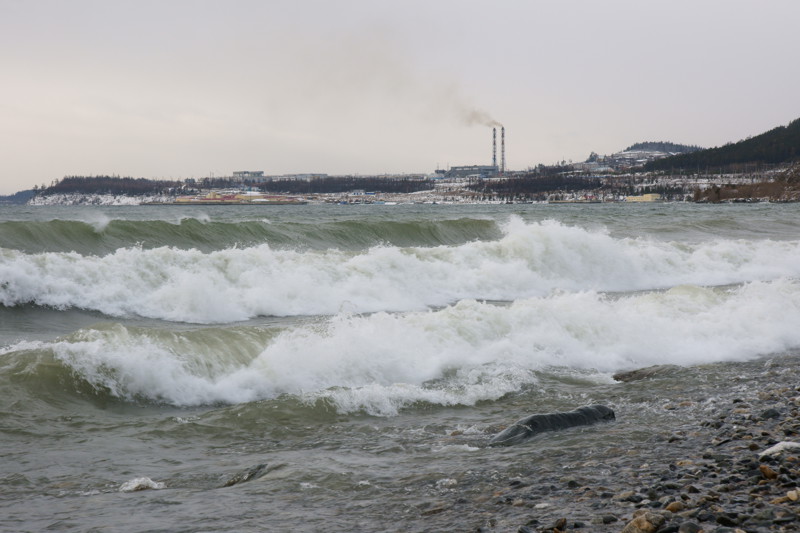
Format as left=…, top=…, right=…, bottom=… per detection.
left=0, top=204, right=800, bottom=531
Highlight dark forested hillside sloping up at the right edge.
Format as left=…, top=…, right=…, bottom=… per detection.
left=644, top=119, right=800, bottom=170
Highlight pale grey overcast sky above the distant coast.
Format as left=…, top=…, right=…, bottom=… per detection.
left=0, top=0, right=800, bottom=194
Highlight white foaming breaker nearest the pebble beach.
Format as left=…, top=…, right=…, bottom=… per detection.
left=17, top=280, right=800, bottom=415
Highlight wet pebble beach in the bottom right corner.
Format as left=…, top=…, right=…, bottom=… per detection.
left=456, top=360, right=800, bottom=533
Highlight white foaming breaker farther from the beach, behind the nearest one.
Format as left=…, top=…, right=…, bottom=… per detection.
left=0, top=218, right=800, bottom=323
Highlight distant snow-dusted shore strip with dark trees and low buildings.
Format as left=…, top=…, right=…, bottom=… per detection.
left=6, top=159, right=800, bottom=205
